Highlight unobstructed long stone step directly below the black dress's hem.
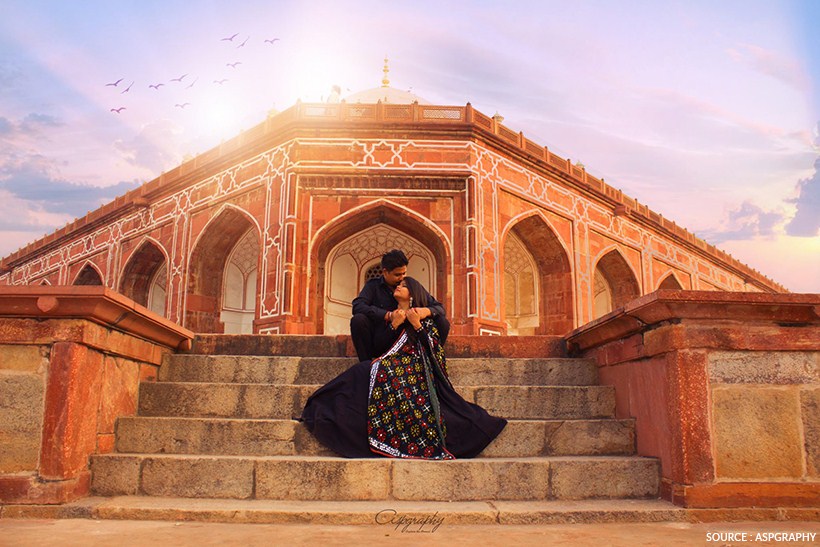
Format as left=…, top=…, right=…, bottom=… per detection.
left=91, top=454, right=659, bottom=501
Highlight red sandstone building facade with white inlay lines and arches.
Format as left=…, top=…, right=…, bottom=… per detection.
left=0, top=102, right=785, bottom=335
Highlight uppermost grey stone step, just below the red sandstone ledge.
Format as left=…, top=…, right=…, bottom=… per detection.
left=159, top=354, right=598, bottom=386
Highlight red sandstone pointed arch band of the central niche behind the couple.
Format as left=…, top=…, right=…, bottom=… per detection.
left=308, top=199, right=452, bottom=333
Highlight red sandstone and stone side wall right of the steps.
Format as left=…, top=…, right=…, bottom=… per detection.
left=566, top=291, right=820, bottom=507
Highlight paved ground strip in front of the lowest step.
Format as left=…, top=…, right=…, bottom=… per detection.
left=0, top=519, right=820, bottom=547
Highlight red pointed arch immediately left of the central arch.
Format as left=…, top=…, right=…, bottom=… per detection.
left=185, top=205, right=260, bottom=333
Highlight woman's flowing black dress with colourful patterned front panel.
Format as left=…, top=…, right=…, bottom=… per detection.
left=300, top=319, right=507, bottom=460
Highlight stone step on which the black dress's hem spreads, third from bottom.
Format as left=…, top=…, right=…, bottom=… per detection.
left=116, top=416, right=635, bottom=458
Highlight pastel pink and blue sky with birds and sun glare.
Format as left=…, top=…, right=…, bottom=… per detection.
left=0, top=0, right=820, bottom=293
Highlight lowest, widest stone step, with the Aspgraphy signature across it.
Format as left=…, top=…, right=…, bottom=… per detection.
left=8, top=496, right=684, bottom=537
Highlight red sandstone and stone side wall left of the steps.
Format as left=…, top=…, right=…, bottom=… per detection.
left=0, top=287, right=193, bottom=504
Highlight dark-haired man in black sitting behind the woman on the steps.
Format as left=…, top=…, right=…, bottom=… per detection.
left=350, top=249, right=450, bottom=361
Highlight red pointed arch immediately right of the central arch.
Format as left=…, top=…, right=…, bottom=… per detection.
left=502, top=211, right=575, bottom=335
